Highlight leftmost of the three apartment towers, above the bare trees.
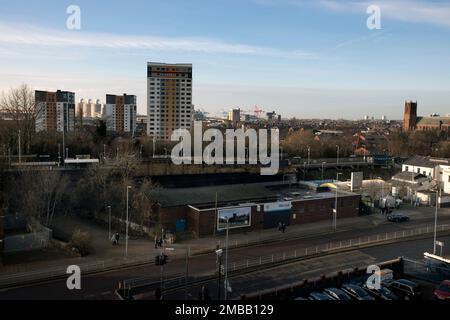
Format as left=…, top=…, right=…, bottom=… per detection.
left=34, top=90, right=75, bottom=132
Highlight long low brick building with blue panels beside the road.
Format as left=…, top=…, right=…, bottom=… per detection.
left=152, top=183, right=361, bottom=237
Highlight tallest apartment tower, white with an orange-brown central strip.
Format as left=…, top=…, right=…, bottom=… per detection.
left=147, top=62, right=193, bottom=140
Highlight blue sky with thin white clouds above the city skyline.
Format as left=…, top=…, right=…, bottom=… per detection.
left=0, top=0, right=450, bottom=119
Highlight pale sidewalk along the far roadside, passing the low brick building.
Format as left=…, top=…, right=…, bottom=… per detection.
left=0, top=206, right=450, bottom=275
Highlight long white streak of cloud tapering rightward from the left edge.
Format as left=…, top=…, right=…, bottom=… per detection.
left=0, top=24, right=318, bottom=59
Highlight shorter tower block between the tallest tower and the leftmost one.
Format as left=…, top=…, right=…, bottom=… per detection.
left=105, top=94, right=137, bottom=135
